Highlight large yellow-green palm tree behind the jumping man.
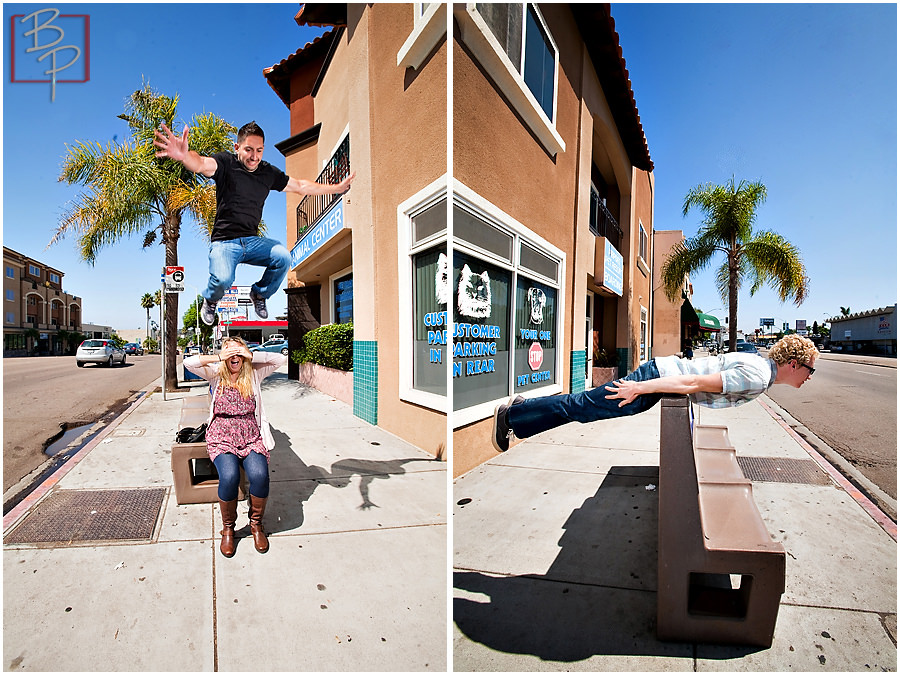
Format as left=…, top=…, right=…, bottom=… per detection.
left=50, top=84, right=236, bottom=389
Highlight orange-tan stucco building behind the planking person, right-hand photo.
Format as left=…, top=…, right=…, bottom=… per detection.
left=451, top=3, right=654, bottom=475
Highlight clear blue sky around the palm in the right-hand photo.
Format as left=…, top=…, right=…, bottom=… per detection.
left=612, top=4, right=897, bottom=330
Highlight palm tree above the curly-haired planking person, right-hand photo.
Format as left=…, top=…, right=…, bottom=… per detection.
left=661, top=178, right=809, bottom=350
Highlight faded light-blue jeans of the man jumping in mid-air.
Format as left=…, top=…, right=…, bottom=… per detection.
left=201, top=237, right=291, bottom=303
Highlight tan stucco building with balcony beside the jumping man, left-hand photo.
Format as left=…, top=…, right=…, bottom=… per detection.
left=265, top=3, right=448, bottom=456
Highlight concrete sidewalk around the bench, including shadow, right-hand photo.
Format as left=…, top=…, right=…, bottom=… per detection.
left=453, top=396, right=897, bottom=672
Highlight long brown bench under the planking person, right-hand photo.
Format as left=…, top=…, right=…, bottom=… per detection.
left=656, top=395, right=785, bottom=647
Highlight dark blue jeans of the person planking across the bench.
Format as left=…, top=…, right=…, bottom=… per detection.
left=509, top=359, right=662, bottom=438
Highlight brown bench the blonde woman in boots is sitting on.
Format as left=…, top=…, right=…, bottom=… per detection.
left=172, top=395, right=247, bottom=504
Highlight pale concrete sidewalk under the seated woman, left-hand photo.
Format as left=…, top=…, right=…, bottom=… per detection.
left=3, top=368, right=447, bottom=671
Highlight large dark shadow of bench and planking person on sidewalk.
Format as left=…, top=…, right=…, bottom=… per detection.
left=453, top=466, right=758, bottom=670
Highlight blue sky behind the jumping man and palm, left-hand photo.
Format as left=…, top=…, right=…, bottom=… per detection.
left=3, top=3, right=323, bottom=330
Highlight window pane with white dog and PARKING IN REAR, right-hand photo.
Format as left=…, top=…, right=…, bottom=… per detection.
left=451, top=251, right=512, bottom=410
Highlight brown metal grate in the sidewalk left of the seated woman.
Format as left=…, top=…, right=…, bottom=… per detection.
left=4, top=488, right=166, bottom=544
